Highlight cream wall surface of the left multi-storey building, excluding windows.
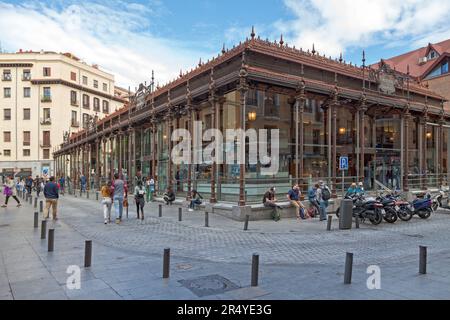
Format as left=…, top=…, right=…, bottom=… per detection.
left=0, top=53, right=123, bottom=175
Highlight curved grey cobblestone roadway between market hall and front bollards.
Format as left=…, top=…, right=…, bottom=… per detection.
left=62, top=197, right=450, bottom=264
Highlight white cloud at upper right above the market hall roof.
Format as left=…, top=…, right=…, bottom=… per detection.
left=274, top=0, right=450, bottom=56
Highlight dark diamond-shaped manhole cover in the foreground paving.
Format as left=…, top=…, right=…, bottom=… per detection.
left=178, top=274, right=240, bottom=297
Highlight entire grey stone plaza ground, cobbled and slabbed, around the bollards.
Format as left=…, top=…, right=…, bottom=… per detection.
left=0, top=191, right=450, bottom=300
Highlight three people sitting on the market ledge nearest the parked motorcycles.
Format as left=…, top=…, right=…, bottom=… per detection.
left=263, top=181, right=331, bottom=221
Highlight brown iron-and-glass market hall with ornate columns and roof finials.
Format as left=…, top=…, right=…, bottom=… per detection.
left=55, top=32, right=450, bottom=206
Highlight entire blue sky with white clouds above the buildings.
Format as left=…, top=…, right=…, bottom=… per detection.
left=0, top=0, right=450, bottom=87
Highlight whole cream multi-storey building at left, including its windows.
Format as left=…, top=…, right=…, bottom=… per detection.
left=0, top=51, right=125, bottom=176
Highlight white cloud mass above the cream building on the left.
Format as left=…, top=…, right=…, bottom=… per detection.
left=0, top=0, right=207, bottom=87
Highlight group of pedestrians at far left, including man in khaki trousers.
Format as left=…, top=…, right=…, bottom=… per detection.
left=2, top=175, right=61, bottom=221
